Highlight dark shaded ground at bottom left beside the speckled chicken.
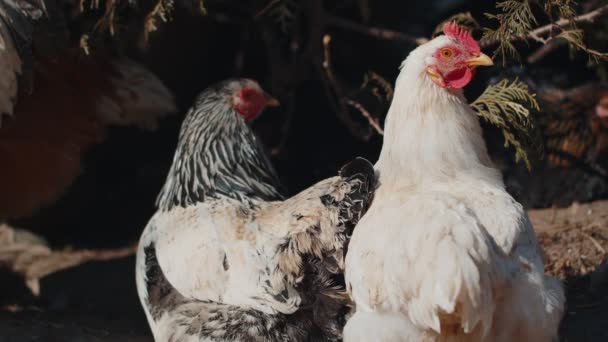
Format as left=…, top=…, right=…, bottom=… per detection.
left=0, top=257, right=152, bottom=342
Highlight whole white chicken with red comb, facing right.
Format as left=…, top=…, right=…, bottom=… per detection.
left=344, top=23, right=564, bottom=342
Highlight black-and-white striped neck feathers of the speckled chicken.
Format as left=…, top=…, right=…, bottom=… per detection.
left=157, top=83, right=282, bottom=210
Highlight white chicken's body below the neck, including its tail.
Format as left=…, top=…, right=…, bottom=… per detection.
left=345, top=180, right=563, bottom=342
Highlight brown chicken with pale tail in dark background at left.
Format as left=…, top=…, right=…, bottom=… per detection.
left=0, top=52, right=176, bottom=219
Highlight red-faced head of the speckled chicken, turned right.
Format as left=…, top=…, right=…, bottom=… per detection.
left=224, top=78, right=279, bottom=121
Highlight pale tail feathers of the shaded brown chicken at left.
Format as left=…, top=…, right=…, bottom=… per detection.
left=97, top=58, right=177, bottom=130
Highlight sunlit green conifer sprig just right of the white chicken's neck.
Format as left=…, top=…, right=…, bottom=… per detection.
left=471, top=79, right=540, bottom=170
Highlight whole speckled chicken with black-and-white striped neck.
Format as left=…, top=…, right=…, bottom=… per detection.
left=136, top=79, right=374, bottom=341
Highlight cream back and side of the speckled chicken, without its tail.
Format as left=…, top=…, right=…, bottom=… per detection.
left=136, top=199, right=334, bottom=342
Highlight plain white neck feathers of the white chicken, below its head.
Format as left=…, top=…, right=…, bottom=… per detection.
left=376, top=38, right=497, bottom=182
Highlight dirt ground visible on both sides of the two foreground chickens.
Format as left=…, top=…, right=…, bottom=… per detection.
left=0, top=201, right=608, bottom=342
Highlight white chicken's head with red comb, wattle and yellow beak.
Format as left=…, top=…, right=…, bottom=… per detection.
left=418, top=22, right=493, bottom=89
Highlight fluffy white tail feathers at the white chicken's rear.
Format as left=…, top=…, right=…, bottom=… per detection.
left=408, top=204, right=507, bottom=336
